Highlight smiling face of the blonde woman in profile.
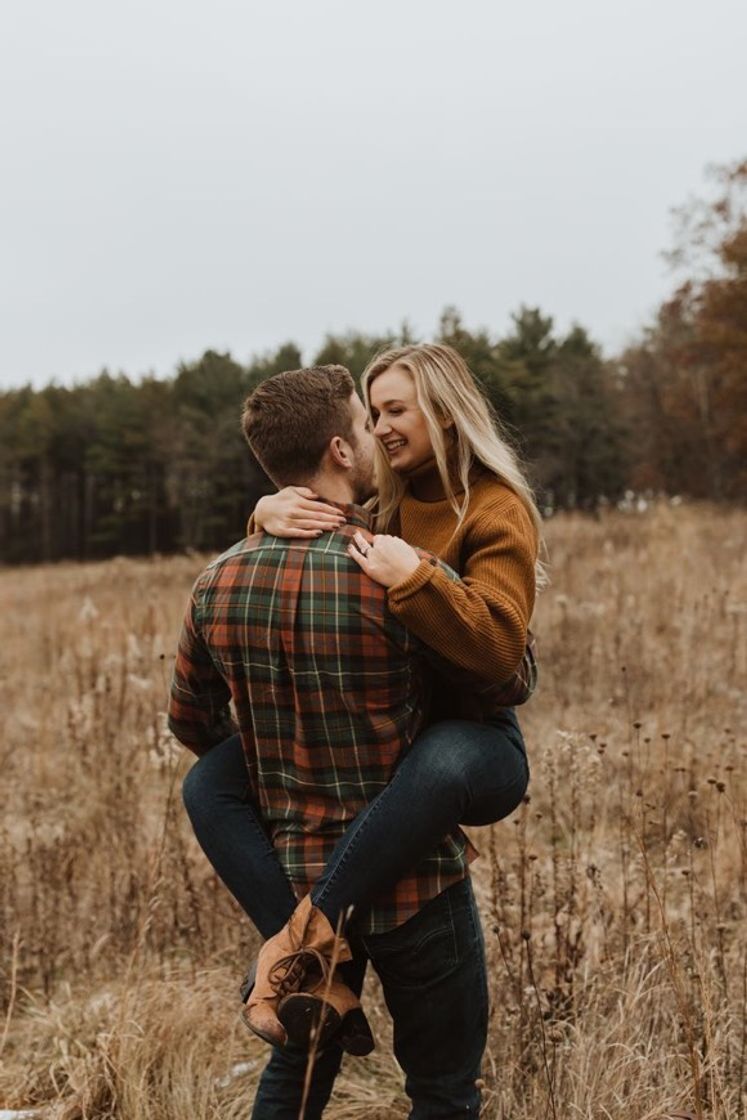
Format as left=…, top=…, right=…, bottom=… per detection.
left=368, top=365, right=433, bottom=474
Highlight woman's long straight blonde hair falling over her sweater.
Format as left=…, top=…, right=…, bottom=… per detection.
left=362, top=343, right=545, bottom=585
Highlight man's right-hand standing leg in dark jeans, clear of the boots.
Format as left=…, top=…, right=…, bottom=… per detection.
left=362, top=879, right=488, bottom=1120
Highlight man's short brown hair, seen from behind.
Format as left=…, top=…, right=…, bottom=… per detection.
left=241, top=365, right=355, bottom=486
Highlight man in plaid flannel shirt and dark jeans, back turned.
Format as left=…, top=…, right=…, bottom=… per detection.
left=169, top=366, right=487, bottom=1120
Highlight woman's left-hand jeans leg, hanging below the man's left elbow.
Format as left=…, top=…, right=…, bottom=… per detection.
left=183, top=735, right=297, bottom=940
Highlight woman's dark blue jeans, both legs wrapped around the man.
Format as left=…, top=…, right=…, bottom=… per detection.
left=183, top=708, right=529, bottom=937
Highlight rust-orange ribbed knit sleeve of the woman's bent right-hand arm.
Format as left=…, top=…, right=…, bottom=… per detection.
left=389, top=497, right=536, bottom=683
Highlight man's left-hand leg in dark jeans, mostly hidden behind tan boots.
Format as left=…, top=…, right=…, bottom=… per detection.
left=252, top=951, right=367, bottom=1120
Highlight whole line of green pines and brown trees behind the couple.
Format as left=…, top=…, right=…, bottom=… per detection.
left=0, top=161, right=747, bottom=563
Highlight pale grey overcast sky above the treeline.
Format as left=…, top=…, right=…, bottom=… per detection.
left=0, top=0, right=747, bottom=388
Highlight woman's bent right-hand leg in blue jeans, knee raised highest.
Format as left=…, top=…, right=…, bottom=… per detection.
left=311, top=709, right=529, bottom=925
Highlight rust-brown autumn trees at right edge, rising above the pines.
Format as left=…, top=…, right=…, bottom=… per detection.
left=622, top=160, right=747, bottom=501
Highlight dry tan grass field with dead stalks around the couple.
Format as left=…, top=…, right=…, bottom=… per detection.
left=0, top=505, right=747, bottom=1120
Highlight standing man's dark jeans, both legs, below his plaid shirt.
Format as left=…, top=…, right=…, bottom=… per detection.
left=252, top=879, right=487, bottom=1120
